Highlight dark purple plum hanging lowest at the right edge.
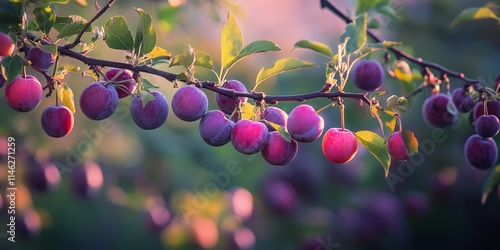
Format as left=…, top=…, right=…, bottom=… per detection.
left=464, top=134, right=498, bottom=170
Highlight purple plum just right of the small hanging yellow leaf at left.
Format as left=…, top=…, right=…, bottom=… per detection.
left=80, top=82, right=118, bottom=121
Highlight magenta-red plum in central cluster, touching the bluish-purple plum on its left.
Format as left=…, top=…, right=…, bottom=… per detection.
left=231, top=119, right=269, bottom=154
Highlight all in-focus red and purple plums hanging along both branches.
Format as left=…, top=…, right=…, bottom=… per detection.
left=0, top=29, right=500, bottom=169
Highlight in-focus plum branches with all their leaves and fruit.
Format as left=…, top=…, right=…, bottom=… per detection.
left=0, top=0, right=500, bottom=205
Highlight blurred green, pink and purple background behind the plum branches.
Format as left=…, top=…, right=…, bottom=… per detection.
left=0, top=0, right=500, bottom=250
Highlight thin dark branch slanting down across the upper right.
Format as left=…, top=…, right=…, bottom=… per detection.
left=320, top=0, right=482, bottom=86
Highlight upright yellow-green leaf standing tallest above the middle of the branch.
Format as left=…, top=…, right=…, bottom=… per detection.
left=220, top=12, right=243, bottom=68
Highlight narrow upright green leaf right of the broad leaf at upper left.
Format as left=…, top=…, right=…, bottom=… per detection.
left=135, top=8, right=156, bottom=56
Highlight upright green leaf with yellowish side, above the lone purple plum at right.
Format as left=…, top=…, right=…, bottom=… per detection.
left=340, top=13, right=368, bottom=54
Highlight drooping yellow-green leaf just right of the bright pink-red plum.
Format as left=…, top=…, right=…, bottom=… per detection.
left=354, top=130, right=391, bottom=177
